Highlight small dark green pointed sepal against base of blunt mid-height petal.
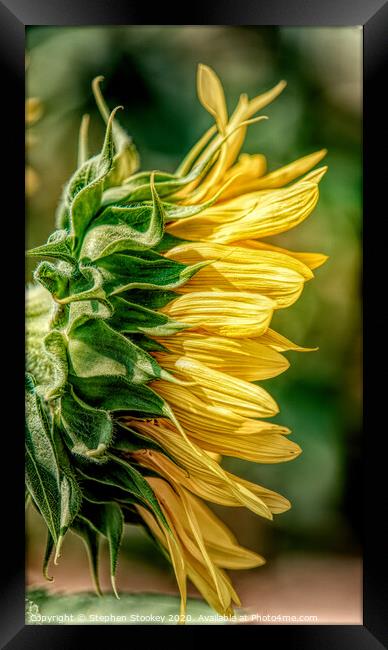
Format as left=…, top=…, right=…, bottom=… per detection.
left=109, top=296, right=188, bottom=336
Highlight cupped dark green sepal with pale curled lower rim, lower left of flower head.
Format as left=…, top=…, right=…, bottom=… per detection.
left=61, top=386, right=113, bottom=462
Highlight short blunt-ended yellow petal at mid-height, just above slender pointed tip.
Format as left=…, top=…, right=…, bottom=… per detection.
left=161, top=291, right=276, bottom=338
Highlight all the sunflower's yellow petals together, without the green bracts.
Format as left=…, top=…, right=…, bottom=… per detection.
left=131, top=60, right=327, bottom=613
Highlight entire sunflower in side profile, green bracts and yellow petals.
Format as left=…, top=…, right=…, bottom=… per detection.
left=26, top=65, right=327, bottom=620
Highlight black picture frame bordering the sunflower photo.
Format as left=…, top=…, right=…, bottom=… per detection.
left=0, top=0, right=388, bottom=650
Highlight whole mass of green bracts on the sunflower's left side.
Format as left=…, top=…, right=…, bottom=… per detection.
left=26, top=81, right=212, bottom=593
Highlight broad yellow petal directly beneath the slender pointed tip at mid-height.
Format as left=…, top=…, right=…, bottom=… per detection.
left=155, top=331, right=290, bottom=381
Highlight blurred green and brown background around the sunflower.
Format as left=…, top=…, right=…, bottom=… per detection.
left=27, top=26, right=362, bottom=623
